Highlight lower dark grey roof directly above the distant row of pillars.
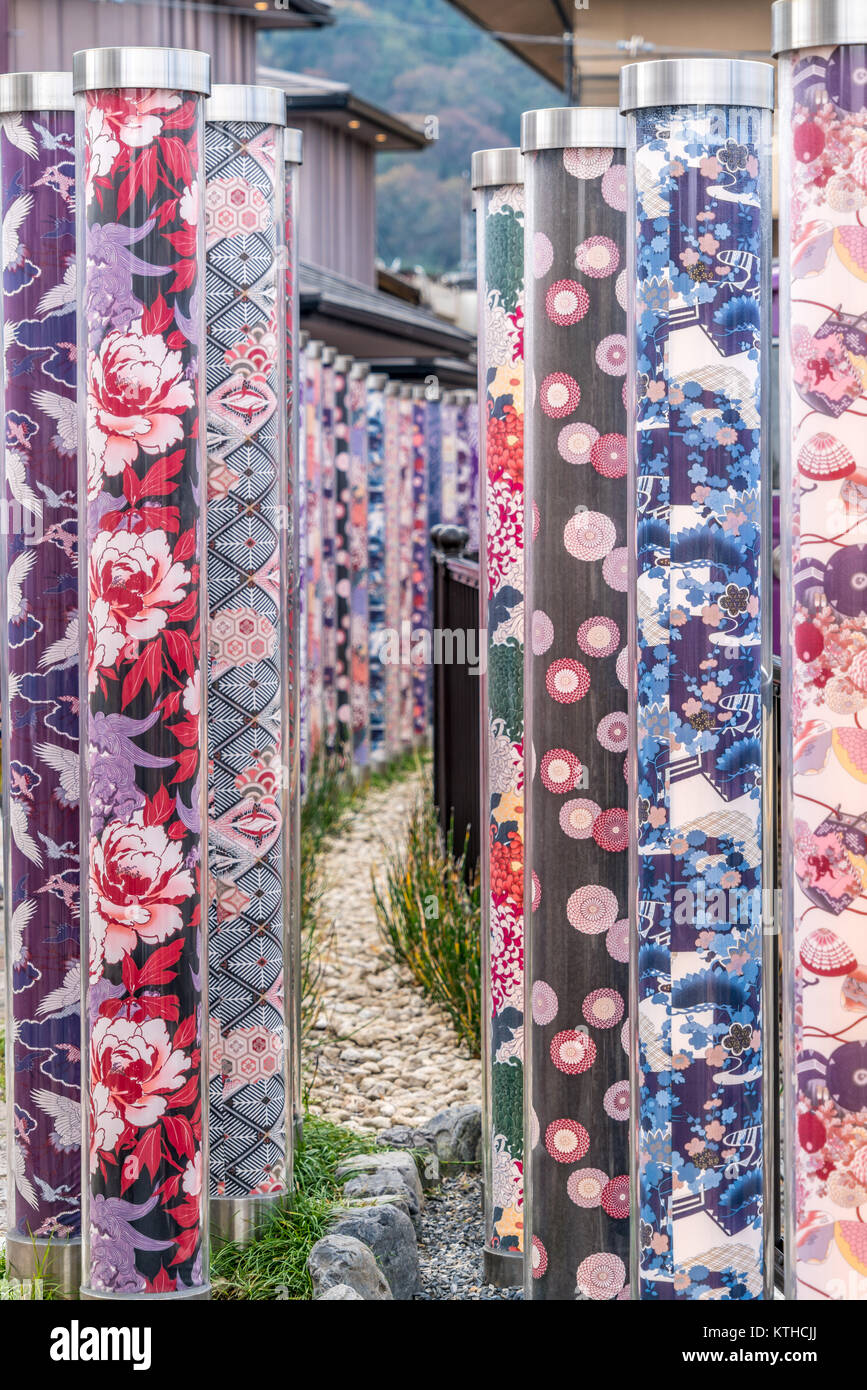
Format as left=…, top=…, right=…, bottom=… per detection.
left=299, top=261, right=475, bottom=381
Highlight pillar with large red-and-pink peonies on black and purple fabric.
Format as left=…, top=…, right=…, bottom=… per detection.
left=72, top=49, right=210, bottom=1300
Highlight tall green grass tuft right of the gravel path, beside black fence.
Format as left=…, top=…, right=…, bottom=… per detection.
left=374, top=784, right=481, bottom=1056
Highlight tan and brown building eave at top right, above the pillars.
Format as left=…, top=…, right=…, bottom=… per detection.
left=452, top=0, right=771, bottom=106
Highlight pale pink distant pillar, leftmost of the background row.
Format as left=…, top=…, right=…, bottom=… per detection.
left=302, top=339, right=325, bottom=780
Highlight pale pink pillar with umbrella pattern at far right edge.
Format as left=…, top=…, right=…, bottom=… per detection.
left=773, top=4, right=867, bottom=1301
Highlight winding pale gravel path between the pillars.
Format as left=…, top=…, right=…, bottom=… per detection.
left=304, top=774, right=481, bottom=1131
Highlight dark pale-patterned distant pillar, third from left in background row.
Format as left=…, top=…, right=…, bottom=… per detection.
left=332, top=357, right=353, bottom=767
